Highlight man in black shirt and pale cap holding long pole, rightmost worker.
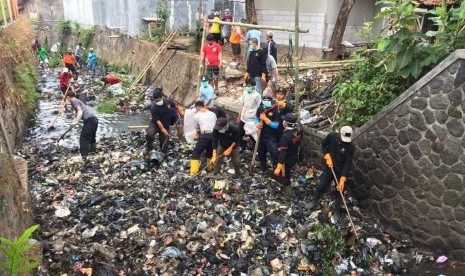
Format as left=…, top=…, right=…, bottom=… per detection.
left=312, top=126, right=355, bottom=212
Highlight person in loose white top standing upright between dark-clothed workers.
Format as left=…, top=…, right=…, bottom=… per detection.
left=237, top=79, right=262, bottom=150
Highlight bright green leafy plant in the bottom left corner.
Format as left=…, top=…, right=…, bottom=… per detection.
left=0, top=225, right=40, bottom=275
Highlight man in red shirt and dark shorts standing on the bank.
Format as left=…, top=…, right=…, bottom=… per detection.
left=200, top=34, right=222, bottom=94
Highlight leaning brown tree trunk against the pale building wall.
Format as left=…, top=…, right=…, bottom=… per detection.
left=324, top=0, right=355, bottom=60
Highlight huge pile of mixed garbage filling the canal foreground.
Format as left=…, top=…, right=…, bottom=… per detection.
left=20, top=132, right=440, bottom=275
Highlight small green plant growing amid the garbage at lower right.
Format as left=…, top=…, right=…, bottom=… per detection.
left=313, top=224, right=346, bottom=275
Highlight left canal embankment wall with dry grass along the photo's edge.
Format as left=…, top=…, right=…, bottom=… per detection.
left=0, top=21, right=36, bottom=246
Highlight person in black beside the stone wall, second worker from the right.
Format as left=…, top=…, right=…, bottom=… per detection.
left=274, top=113, right=301, bottom=186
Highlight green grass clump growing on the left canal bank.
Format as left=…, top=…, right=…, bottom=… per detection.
left=13, top=63, right=39, bottom=113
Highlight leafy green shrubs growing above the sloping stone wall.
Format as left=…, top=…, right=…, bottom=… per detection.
left=333, top=0, right=465, bottom=126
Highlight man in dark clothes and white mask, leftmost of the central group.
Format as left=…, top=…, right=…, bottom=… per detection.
left=145, top=89, right=175, bottom=153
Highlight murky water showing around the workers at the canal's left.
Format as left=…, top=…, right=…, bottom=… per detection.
left=26, top=70, right=150, bottom=147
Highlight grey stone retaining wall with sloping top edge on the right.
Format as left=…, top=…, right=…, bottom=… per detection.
left=303, top=50, right=465, bottom=261
